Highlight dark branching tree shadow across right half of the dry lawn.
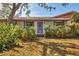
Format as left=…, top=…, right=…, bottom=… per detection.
left=35, top=41, right=79, bottom=56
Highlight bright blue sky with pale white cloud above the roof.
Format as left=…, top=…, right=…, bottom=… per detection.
left=23, top=3, right=79, bottom=17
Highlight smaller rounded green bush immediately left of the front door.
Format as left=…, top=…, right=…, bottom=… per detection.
left=22, top=26, right=36, bottom=41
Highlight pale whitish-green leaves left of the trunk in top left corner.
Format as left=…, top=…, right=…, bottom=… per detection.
left=0, top=3, right=11, bottom=18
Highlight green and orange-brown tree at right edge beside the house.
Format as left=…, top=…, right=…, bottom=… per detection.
left=68, top=12, right=79, bottom=36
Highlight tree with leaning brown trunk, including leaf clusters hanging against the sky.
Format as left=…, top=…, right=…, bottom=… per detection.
left=2, top=3, right=67, bottom=23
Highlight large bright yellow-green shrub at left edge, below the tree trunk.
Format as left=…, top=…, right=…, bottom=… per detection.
left=0, top=23, right=19, bottom=50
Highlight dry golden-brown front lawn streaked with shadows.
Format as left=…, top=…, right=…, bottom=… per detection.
left=0, top=38, right=79, bottom=56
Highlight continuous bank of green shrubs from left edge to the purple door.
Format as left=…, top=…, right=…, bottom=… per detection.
left=0, top=23, right=36, bottom=51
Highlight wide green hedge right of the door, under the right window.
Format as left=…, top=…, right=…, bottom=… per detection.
left=45, top=25, right=72, bottom=37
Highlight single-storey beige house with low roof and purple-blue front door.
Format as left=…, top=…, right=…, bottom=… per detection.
left=0, top=11, right=77, bottom=35
